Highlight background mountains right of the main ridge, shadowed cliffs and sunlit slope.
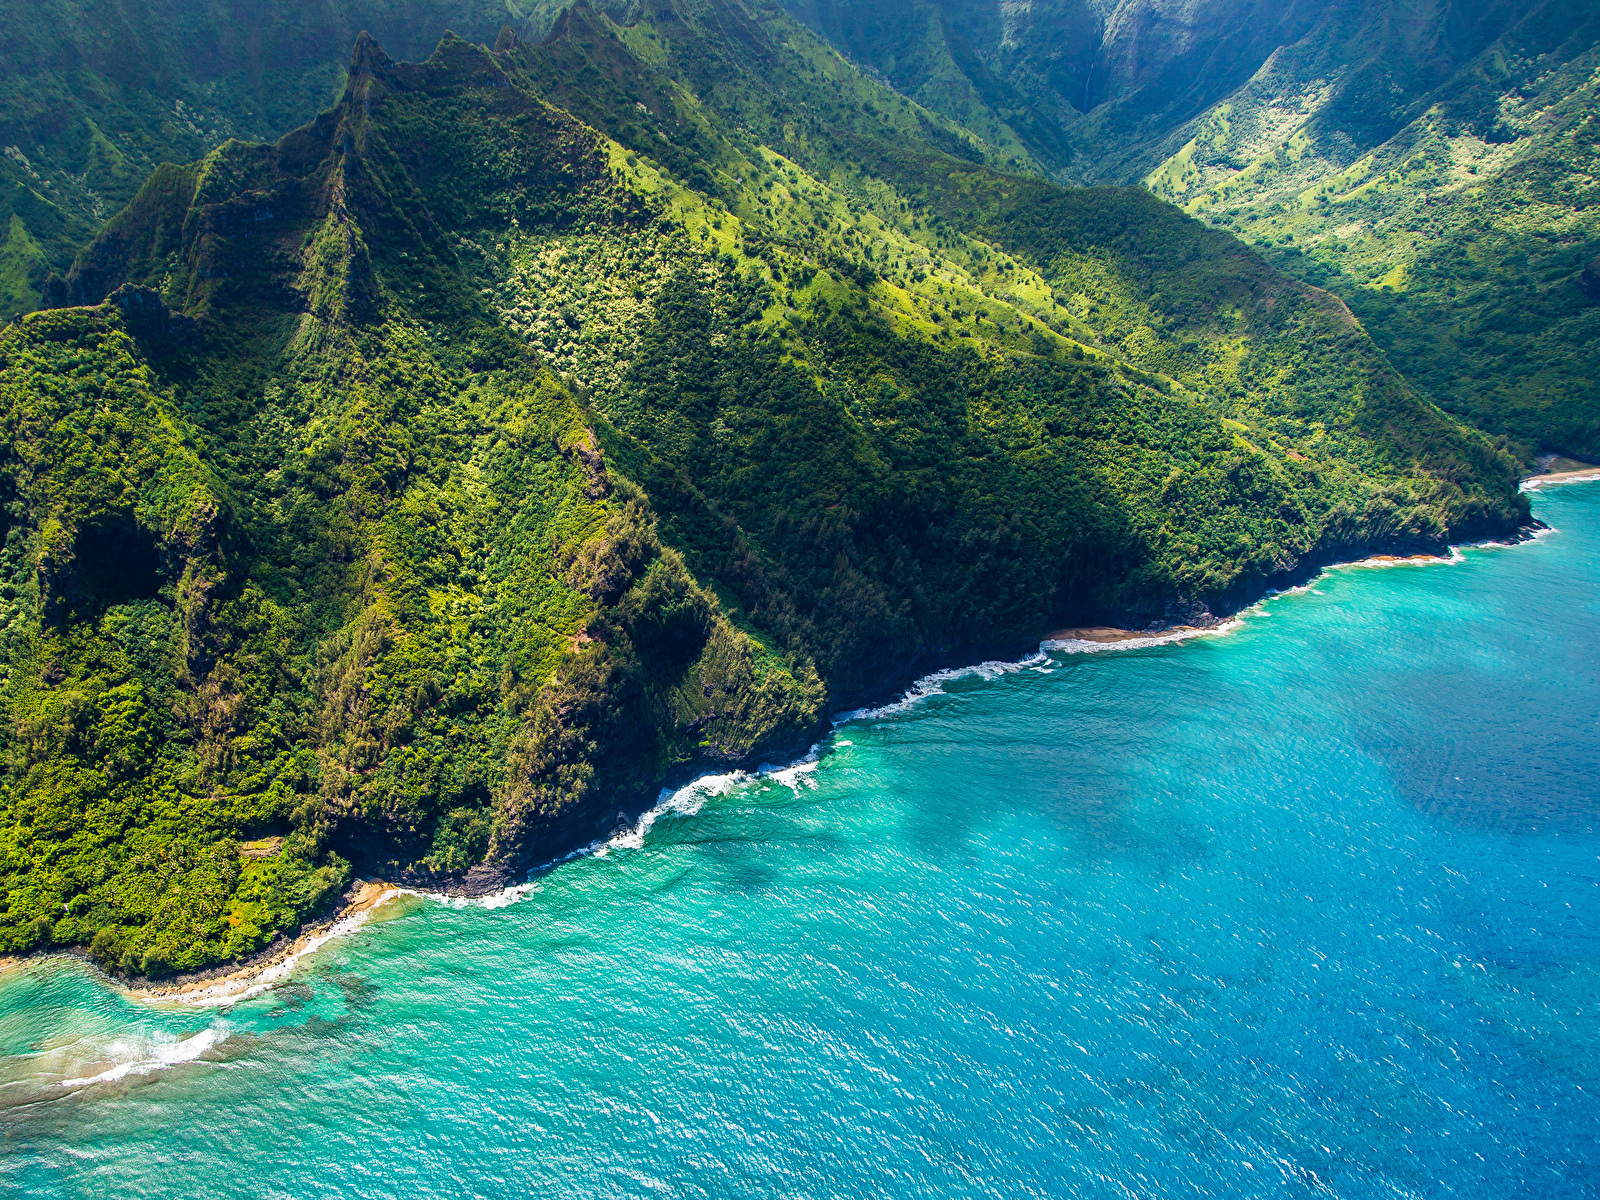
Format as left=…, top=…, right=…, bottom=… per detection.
left=777, top=0, right=1600, bottom=461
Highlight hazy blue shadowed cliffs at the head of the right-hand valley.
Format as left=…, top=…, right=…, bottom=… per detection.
left=774, top=0, right=1592, bottom=184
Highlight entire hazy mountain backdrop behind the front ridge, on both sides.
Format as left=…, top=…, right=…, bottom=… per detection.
left=9, top=0, right=1600, bottom=462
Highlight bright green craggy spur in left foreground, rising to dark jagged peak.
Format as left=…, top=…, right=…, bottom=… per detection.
left=0, top=40, right=821, bottom=973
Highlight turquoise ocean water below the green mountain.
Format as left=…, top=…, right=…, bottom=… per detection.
left=0, top=485, right=1600, bottom=1197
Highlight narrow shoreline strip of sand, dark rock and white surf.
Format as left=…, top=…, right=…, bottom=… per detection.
left=25, top=483, right=1600, bottom=1008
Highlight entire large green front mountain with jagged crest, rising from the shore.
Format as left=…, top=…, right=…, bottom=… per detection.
left=0, top=10, right=1526, bottom=974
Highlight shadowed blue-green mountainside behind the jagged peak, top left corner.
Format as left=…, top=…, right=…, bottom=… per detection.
left=0, top=0, right=528, bottom=317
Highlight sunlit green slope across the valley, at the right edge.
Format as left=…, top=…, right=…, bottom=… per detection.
left=1150, top=3, right=1600, bottom=461
